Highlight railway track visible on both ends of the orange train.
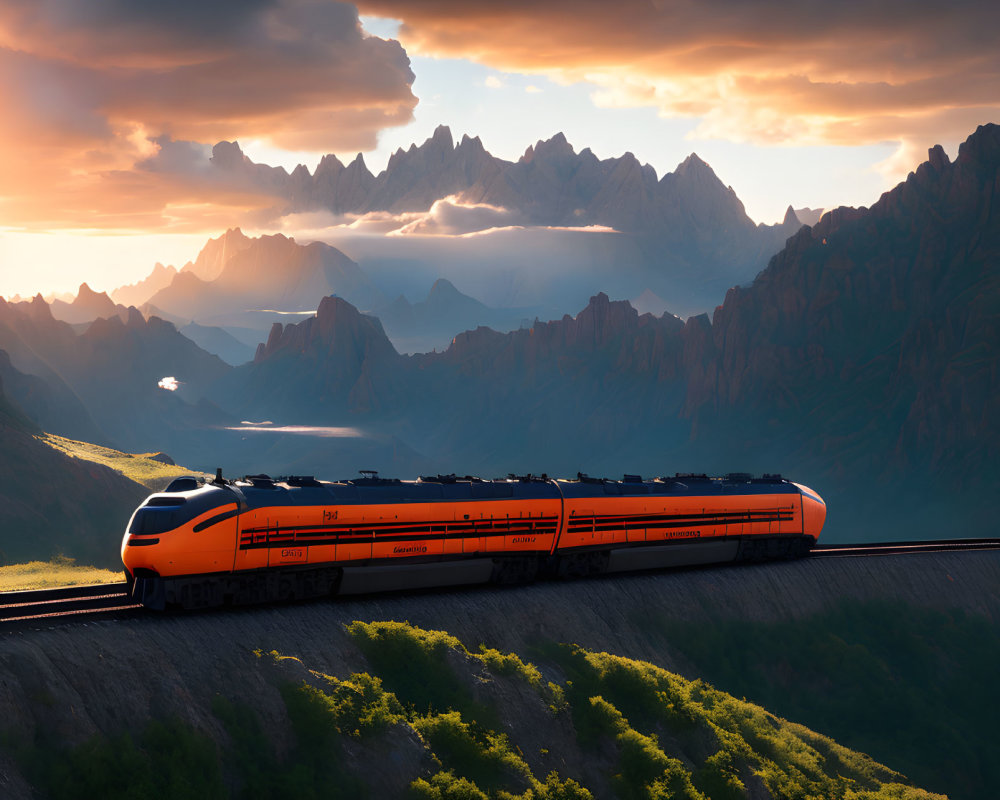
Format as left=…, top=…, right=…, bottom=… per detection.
left=0, top=538, right=1000, bottom=629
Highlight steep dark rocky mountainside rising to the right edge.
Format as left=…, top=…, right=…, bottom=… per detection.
left=686, top=126, right=1000, bottom=488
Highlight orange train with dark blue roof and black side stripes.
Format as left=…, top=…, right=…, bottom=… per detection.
left=122, top=470, right=826, bottom=609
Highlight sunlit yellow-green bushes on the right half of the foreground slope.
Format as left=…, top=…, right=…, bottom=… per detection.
left=532, top=646, right=929, bottom=800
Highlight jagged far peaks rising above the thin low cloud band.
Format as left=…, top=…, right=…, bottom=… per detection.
left=212, top=125, right=788, bottom=235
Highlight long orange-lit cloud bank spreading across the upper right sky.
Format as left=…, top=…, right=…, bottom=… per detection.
left=359, top=0, right=1000, bottom=162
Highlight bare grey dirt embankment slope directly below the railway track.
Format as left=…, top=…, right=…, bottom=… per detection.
left=0, top=552, right=988, bottom=798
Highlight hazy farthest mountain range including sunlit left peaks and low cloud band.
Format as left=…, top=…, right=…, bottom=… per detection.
left=103, top=126, right=808, bottom=350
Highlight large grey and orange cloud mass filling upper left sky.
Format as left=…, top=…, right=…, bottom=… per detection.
left=0, top=0, right=416, bottom=229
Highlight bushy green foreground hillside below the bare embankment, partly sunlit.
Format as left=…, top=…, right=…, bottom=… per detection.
left=17, top=622, right=943, bottom=800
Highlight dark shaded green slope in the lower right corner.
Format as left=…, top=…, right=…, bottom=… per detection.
left=635, top=602, right=1000, bottom=798
